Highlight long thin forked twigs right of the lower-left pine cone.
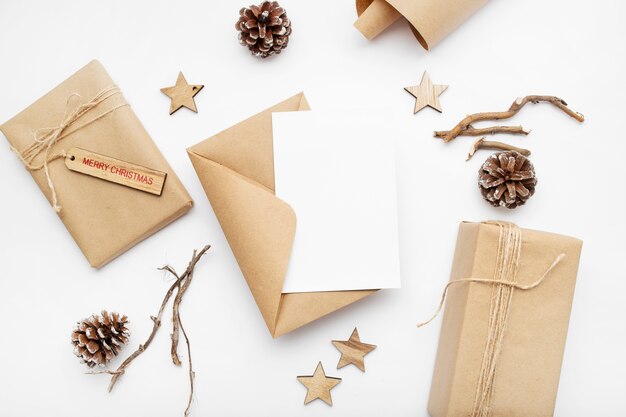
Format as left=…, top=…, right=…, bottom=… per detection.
left=90, top=245, right=211, bottom=416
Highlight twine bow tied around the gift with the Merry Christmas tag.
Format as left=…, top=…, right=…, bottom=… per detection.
left=11, top=86, right=128, bottom=213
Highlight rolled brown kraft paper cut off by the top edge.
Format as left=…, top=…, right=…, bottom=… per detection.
left=354, top=0, right=489, bottom=50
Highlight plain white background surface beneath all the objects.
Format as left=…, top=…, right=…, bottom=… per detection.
left=0, top=0, right=626, bottom=417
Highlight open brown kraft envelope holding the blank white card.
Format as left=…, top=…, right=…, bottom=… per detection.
left=187, top=93, right=376, bottom=337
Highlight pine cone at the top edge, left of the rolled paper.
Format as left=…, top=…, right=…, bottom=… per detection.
left=235, top=1, right=291, bottom=58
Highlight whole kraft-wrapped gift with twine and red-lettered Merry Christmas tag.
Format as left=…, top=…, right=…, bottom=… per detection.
left=0, top=61, right=193, bottom=268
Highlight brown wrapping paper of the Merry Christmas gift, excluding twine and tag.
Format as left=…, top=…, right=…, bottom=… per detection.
left=0, top=61, right=193, bottom=268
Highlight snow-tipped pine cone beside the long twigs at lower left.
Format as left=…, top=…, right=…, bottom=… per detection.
left=72, top=311, right=130, bottom=368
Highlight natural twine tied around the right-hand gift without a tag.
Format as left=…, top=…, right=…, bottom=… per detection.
left=417, top=222, right=565, bottom=417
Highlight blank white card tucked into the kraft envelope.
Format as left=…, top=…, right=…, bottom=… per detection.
left=273, top=111, right=400, bottom=293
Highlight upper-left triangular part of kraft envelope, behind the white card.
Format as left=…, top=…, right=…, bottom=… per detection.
left=189, top=93, right=310, bottom=190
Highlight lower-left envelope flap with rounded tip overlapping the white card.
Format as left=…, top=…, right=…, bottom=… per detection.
left=188, top=150, right=296, bottom=334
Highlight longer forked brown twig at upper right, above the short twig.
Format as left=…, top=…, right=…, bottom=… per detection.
left=435, top=95, right=585, bottom=142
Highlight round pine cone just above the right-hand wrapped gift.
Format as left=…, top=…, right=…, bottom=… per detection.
left=478, top=151, right=537, bottom=209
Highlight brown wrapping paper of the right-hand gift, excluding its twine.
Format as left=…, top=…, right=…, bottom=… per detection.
left=428, top=223, right=582, bottom=417
